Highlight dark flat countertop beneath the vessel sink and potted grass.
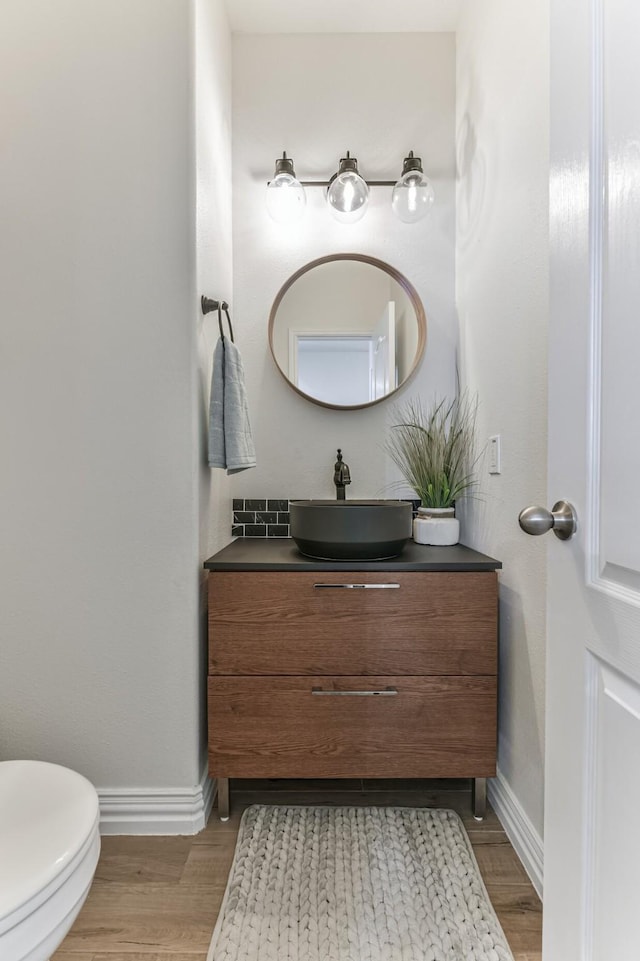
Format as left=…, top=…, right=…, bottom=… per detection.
left=204, top=537, right=502, bottom=571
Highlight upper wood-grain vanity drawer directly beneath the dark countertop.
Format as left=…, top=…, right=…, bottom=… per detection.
left=209, top=571, right=497, bottom=675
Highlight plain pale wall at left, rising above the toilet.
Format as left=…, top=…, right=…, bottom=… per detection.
left=0, top=0, right=230, bottom=789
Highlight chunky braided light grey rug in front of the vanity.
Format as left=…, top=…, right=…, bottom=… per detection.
left=207, top=805, right=513, bottom=961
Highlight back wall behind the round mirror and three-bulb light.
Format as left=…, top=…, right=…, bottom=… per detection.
left=232, top=34, right=457, bottom=497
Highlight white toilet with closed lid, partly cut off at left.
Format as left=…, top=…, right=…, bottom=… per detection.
left=0, top=761, right=100, bottom=961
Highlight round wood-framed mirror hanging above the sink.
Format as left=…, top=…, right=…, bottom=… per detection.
left=269, top=254, right=427, bottom=410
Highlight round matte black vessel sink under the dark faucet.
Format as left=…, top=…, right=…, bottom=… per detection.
left=289, top=500, right=413, bottom=561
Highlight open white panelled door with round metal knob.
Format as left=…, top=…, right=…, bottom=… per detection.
left=543, top=0, right=640, bottom=961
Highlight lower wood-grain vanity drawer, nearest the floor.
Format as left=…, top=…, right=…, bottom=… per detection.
left=208, top=676, right=496, bottom=778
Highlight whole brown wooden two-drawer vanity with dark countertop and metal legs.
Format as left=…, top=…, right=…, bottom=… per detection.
left=205, top=538, right=502, bottom=818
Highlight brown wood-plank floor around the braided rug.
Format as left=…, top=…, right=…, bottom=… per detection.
left=54, top=781, right=542, bottom=961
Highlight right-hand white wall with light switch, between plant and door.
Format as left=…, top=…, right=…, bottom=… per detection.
left=457, top=0, right=549, bottom=836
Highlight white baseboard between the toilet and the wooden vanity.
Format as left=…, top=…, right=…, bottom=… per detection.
left=98, top=770, right=215, bottom=834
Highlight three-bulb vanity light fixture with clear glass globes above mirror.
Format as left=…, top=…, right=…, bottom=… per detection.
left=267, top=150, right=435, bottom=224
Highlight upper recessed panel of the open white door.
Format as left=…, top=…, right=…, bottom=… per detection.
left=594, top=0, right=640, bottom=590
